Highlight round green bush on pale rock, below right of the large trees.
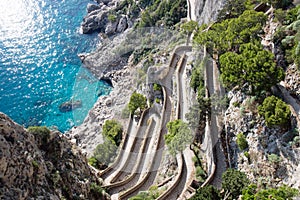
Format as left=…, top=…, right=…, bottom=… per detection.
left=258, top=96, right=291, bottom=128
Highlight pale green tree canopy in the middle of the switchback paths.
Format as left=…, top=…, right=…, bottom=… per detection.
left=164, top=119, right=193, bottom=155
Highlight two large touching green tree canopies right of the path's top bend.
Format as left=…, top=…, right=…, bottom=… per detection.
left=194, top=1, right=284, bottom=94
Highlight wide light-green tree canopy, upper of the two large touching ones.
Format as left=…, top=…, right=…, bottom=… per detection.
left=194, top=10, right=267, bottom=55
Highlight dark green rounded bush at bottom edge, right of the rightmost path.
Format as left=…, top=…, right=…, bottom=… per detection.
left=222, top=169, right=250, bottom=199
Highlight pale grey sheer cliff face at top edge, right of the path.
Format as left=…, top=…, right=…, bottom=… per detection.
left=187, top=0, right=226, bottom=24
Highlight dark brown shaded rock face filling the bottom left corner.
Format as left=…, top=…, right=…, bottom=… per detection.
left=0, top=113, right=105, bottom=200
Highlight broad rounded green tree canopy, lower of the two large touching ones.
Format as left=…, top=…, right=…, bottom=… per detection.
left=220, top=43, right=284, bottom=93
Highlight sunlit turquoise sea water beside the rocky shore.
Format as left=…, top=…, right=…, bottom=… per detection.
left=0, top=0, right=110, bottom=132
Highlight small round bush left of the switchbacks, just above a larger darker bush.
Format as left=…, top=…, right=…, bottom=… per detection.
left=102, top=119, right=123, bottom=146
